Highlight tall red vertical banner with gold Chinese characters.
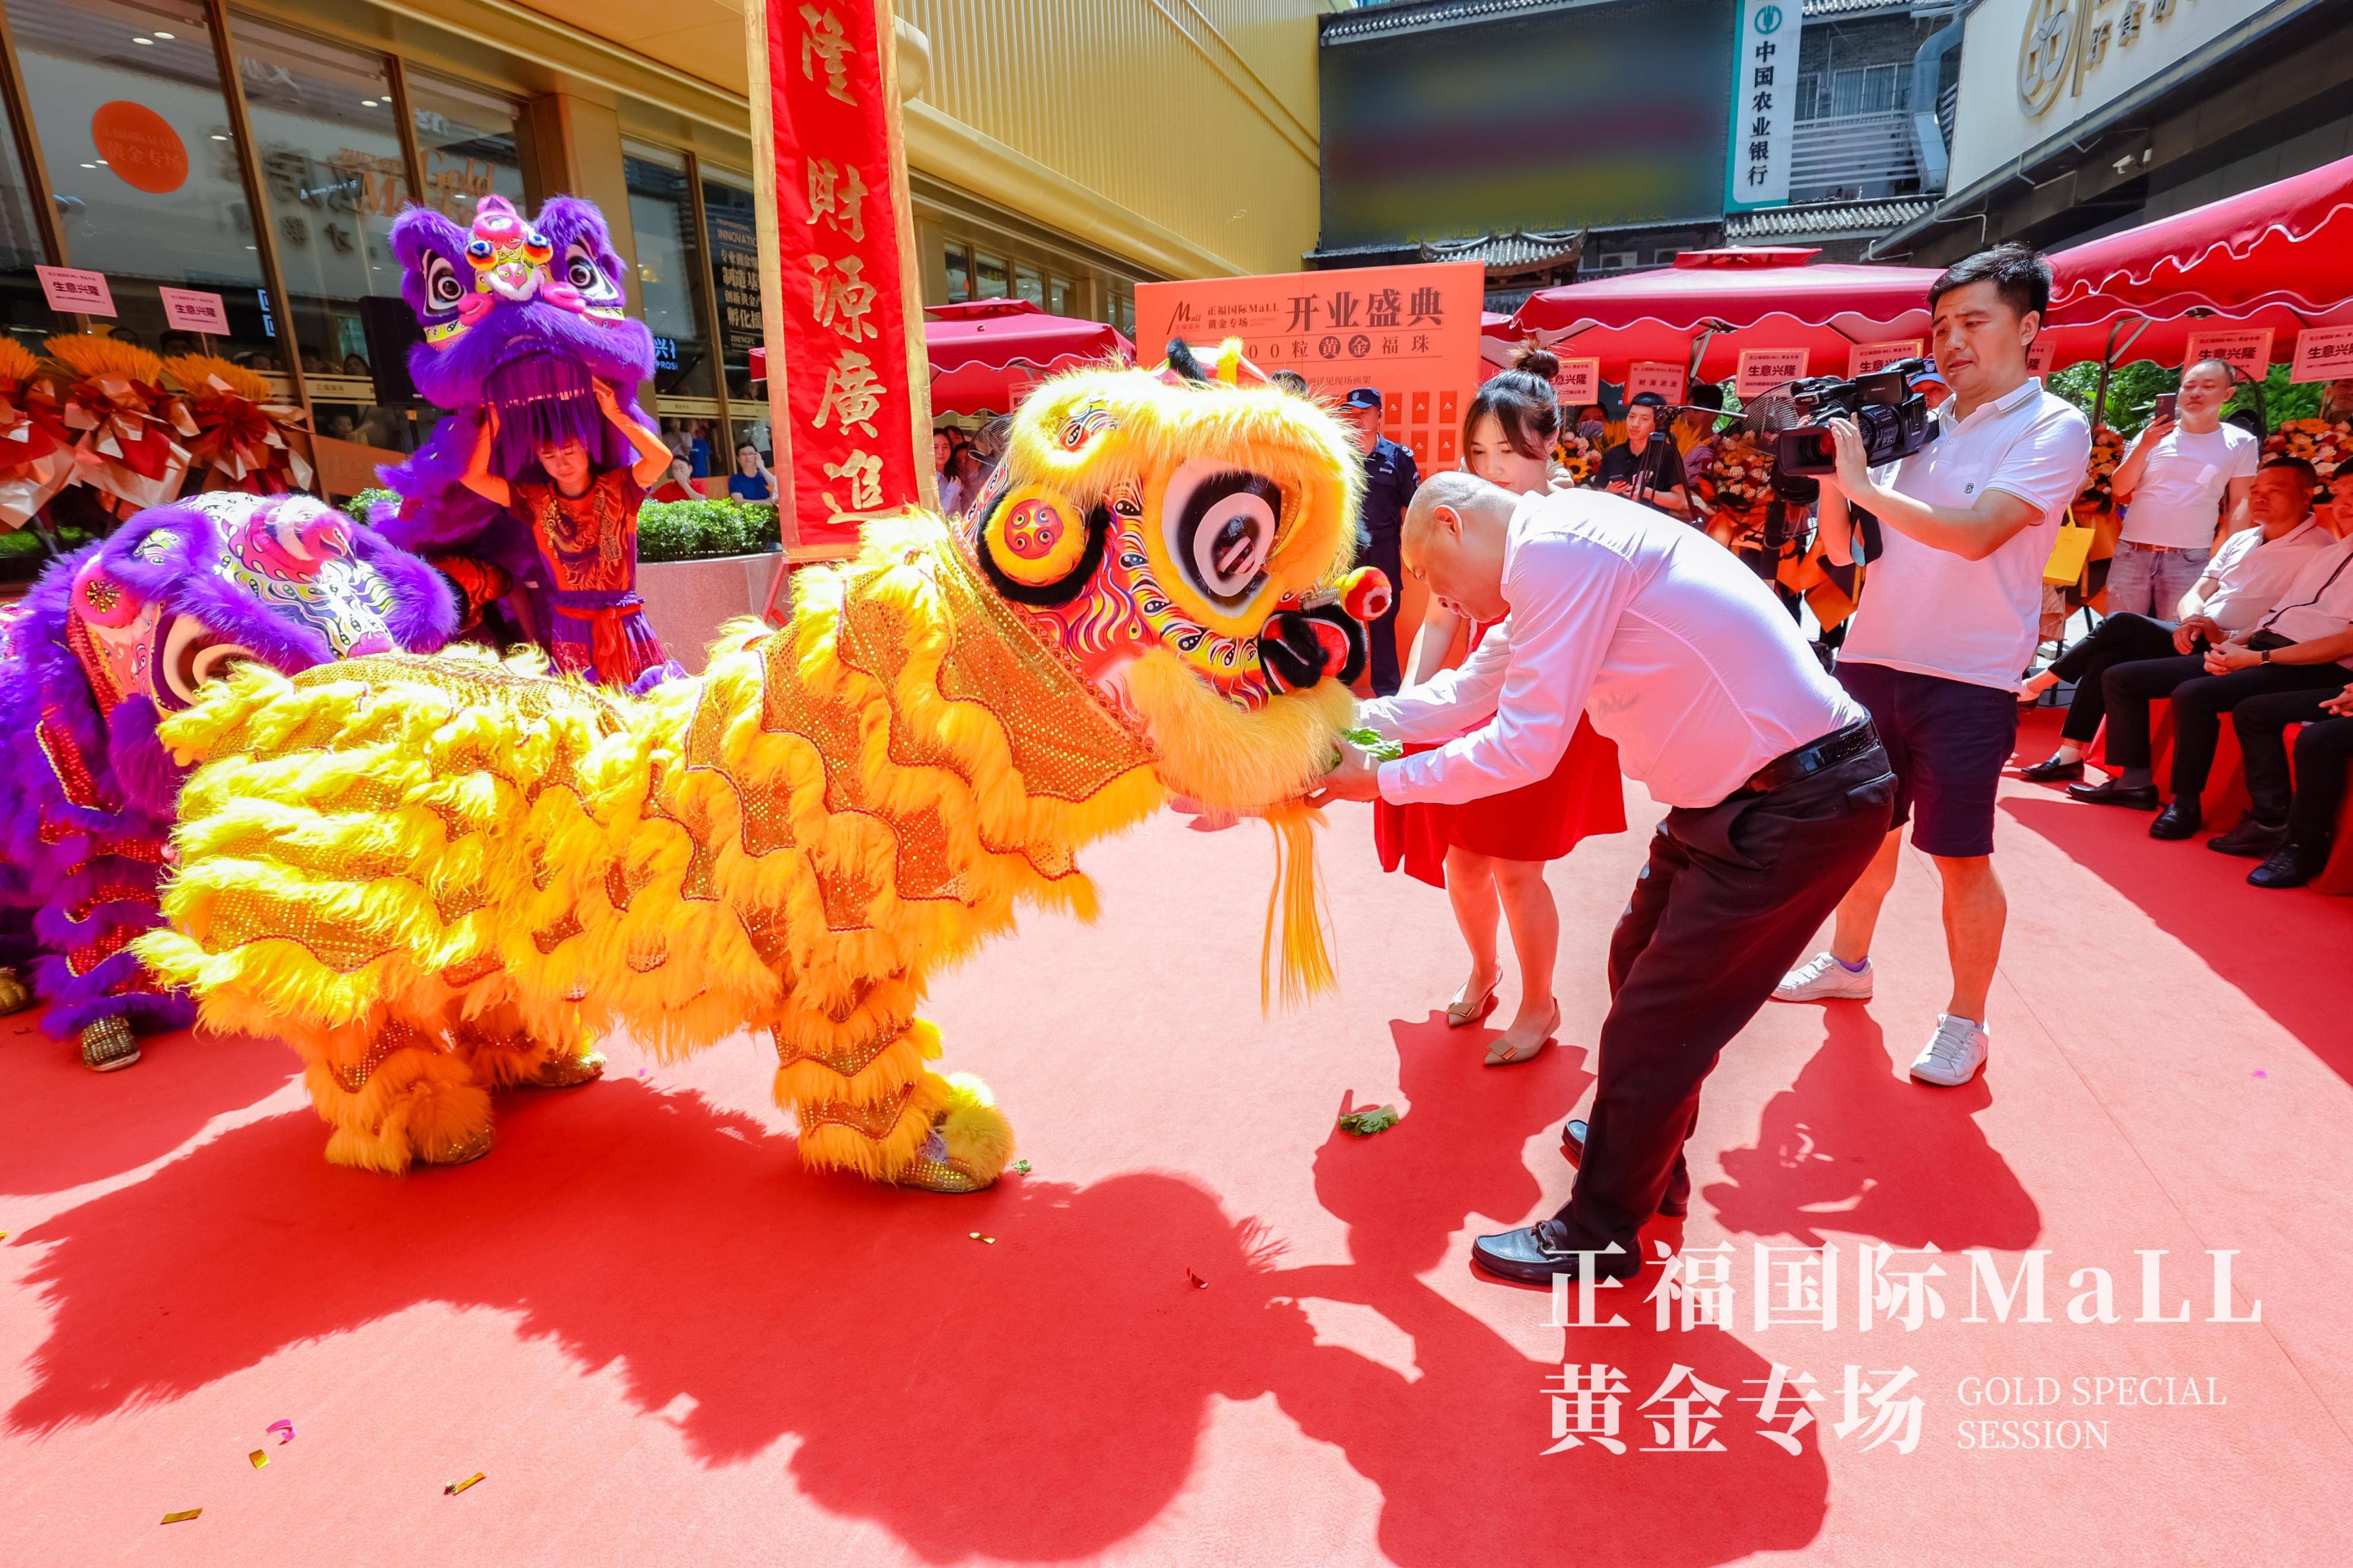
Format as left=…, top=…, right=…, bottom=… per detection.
left=744, top=0, right=936, bottom=564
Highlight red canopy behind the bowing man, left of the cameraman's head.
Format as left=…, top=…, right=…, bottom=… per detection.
left=1511, top=247, right=1936, bottom=381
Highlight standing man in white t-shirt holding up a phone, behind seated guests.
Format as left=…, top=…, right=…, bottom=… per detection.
left=2109, top=360, right=2263, bottom=616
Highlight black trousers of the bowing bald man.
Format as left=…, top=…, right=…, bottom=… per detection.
left=1555, top=745, right=1897, bottom=1279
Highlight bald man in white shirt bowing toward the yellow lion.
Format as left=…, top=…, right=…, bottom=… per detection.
left=1315, top=472, right=1894, bottom=1286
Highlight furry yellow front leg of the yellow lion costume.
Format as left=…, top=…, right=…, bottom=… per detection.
left=774, top=978, right=1014, bottom=1192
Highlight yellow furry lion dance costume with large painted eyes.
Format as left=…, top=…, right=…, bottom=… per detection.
left=139, top=344, right=1386, bottom=1192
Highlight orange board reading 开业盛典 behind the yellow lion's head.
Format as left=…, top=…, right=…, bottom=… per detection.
left=1136, top=261, right=1487, bottom=472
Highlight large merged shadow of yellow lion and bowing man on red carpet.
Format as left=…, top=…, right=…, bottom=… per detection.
left=5, top=1025, right=1826, bottom=1568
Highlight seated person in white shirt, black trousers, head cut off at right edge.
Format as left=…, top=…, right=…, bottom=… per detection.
left=2068, top=482, right=2353, bottom=839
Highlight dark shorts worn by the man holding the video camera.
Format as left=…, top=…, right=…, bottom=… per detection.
left=1836, top=663, right=2019, bottom=860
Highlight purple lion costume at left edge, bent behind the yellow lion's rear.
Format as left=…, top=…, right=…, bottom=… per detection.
left=0, top=491, right=456, bottom=1072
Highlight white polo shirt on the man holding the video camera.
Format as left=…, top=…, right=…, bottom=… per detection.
left=1838, top=376, right=2092, bottom=691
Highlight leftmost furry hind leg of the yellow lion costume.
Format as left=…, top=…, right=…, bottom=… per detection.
left=280, top=1018, right=492, bottom=1175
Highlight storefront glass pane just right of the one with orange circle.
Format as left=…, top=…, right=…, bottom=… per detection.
left=231, top=17, right=414, bottom=451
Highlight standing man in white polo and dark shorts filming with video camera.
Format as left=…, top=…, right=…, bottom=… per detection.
left=1774, top=244, right=2092, bottom=1086
